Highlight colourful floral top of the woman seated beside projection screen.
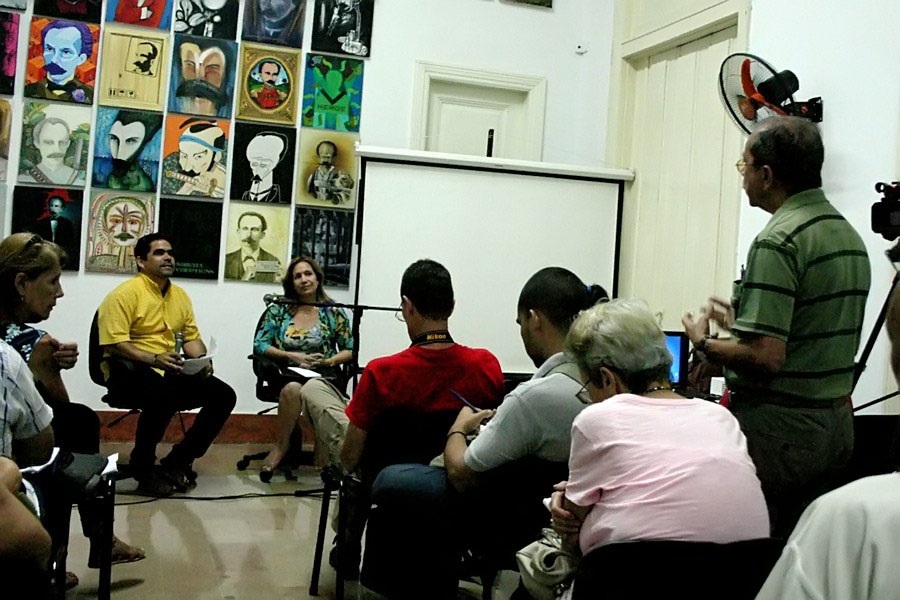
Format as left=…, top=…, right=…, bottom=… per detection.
left=253, top=304, right=353, bottom=358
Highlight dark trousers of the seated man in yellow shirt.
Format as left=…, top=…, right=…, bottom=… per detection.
left=107, top=365, right=237, bottom=471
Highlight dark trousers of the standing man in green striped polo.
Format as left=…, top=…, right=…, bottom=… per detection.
left=730, top=399, right=853, bottom=538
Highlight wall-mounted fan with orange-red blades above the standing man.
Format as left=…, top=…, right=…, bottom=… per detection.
left=719, top=52, right=822, bottom=133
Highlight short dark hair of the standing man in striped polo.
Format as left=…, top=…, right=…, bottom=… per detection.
left=749, top=117, right=825, bottom=194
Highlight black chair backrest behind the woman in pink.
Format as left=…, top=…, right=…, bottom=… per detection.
left=573, top=538, right=784, bottom=600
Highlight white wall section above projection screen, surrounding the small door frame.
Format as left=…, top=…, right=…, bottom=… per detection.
left=360, top=0, right=627, bottom=167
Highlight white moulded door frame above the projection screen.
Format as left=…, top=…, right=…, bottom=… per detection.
left=410, top=60, right=547, bottom=161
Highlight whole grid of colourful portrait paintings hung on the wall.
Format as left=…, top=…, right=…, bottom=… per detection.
left=0, top=0, right=374, bottom=287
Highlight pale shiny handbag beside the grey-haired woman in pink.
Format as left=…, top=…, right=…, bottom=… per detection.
left=516, top=527, right=581, bottom=600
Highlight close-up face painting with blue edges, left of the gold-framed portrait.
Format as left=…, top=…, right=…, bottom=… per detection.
left=169, top=35, right=237, bottom=119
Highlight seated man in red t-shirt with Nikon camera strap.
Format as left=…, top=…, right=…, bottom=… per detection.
left=300, top=259, right=503, bottom=574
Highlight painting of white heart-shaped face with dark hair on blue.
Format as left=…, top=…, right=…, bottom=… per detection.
left=91, top=106, right=163, bottom=192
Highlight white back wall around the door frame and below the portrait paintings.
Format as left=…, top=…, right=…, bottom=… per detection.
left=0, top=0, right=612, bottom=413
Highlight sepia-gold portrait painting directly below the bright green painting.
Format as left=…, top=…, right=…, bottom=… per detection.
left=295, top=129, right=359, bottom=210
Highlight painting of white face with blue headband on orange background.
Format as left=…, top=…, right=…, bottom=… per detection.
left=160, top=115, right=231, bottom=200
